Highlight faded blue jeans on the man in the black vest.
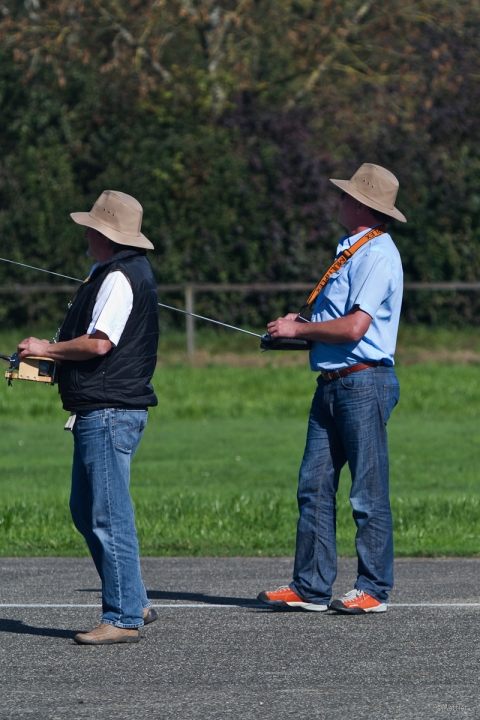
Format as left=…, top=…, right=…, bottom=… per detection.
left=70, top=408, right=151, bottom=628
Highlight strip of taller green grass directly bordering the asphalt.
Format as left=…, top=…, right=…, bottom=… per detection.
left=0, top=491, right=480, bottom=557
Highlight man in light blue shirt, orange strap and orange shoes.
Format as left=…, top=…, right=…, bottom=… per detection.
left=258, top=163, right=406, bottom=614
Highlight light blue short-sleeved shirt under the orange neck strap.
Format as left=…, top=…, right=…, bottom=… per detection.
left=310, top=230, right=403, bottom=372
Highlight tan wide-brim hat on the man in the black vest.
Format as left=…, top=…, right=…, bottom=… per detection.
left=70, top=190, right=154, bottom=250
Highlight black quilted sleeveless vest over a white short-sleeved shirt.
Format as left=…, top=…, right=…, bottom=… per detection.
left=58, top=250, right=158, bottom=412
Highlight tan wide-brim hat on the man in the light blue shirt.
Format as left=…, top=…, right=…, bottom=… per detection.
left=330, top=163, right=407, bottom=222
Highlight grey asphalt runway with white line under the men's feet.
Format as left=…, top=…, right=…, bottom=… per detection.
left=0, top=558, right=480, bottom=720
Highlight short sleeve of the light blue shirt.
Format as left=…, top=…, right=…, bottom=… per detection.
left=346, top=250, right=394, bottom=318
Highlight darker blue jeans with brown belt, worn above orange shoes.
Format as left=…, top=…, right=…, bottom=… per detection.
left=290, top=366, right=400, bottom=605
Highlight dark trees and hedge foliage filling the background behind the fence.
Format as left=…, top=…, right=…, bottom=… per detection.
left=0, top=0, right=480, bottom=324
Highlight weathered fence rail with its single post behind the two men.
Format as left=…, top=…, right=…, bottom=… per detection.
left=0, top=282, right=480, bottom=357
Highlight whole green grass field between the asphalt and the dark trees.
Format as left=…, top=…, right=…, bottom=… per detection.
left=0, top=331, right=480, bottom=556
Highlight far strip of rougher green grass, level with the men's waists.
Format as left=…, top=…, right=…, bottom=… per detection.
left=0, top=362, right=480, bottom=423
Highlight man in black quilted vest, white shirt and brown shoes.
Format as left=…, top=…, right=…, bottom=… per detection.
left=19, top=190, right=158, bottom=645
